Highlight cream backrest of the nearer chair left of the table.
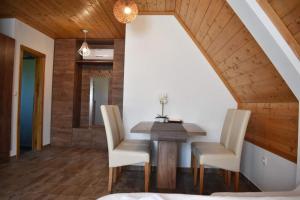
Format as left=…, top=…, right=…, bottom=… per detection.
left=100, top=105, right=120, bottom=152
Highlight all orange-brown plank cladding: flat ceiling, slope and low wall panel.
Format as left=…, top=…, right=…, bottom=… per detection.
left=0, top=0, right=299, bottom=162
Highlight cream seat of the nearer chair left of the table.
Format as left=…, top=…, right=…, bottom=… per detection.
left=109, top=142, right=150, bottom=167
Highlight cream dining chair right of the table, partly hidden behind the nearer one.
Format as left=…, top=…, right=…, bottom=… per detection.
left=191, top=109, right=236, bottom=186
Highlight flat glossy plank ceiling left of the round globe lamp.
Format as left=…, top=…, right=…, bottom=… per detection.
left=0, top=0, right=125, bottom=39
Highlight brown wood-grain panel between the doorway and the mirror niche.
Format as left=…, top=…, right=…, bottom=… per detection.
left=51, top=39, right=76, bottom=146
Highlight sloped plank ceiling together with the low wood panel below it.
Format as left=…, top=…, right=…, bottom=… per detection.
left=175, top=0, right=299, bottom=162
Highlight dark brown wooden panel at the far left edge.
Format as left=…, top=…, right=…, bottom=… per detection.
left=0, top=33, right=15, bottom=162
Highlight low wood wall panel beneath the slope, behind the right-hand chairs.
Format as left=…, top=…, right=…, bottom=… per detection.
left=239, top=102, right=299, bottom=162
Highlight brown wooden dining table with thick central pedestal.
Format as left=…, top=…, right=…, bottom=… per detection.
left=131, top=121, right=206, bottom=190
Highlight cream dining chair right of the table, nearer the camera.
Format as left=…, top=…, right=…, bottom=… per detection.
left=193, top=110, right=251, bottom=194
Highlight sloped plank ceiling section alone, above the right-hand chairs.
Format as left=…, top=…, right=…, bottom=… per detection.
left=176, top=0, right=296, bottom=103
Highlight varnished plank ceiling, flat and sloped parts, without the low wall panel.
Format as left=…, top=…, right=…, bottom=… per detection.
left=0, top=0, right=300, bottom=103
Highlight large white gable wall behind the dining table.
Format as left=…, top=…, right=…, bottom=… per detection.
left=123, top=16, right=237, bottom=167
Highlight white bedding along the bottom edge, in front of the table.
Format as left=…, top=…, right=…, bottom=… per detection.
left=98, top=193, right=300, bottom=200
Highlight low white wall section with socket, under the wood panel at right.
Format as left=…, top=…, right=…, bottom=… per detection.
left=241, top=142, right=297, bottom=191
